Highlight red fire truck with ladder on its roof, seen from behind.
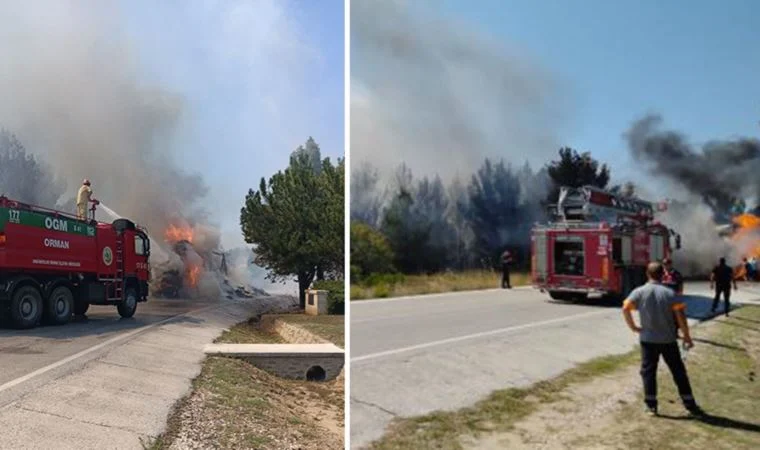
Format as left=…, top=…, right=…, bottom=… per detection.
left=531, top=186, right=681, bottom=300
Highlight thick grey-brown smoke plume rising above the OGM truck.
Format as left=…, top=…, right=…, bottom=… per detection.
left=0, top=0, right=218, bottom=248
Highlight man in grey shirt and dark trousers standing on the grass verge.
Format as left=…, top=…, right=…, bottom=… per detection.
left=623, top=262, right=703, bottom=416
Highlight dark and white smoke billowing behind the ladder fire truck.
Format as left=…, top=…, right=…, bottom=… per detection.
left=625, top=115, right=760, bottom=274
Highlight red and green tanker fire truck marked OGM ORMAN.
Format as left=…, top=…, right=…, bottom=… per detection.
left=0, top=197, right=150, bottom=328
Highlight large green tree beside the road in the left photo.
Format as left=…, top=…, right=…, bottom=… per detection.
left=240, top=137, right=345, bottom=309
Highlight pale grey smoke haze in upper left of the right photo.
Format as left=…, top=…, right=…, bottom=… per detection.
left=351, top=1, right=566, bottom=179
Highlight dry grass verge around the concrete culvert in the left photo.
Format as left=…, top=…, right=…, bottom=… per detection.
left=143, top=314, right=345, bottom=450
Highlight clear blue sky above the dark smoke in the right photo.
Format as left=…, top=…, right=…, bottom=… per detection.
left=442, top=0, right=760, bottom=178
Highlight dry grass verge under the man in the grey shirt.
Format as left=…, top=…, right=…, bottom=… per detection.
left=370, top=306, right=760, bottom=450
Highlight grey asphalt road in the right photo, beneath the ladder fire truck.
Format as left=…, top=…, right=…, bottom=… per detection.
left=350, top=283, right=760, bottom=448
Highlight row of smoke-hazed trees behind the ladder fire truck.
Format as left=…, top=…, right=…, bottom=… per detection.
left=351, top=148, right=620, bottom=282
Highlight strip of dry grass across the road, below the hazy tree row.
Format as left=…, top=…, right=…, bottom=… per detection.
left=351, top=270, right=530, bottom=300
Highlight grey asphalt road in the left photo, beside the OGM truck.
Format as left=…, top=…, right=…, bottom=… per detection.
left=0, top=297, right=293, bottom=450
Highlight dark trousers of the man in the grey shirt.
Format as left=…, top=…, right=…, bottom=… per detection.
left=641, top=342, right=696, bottom=408
